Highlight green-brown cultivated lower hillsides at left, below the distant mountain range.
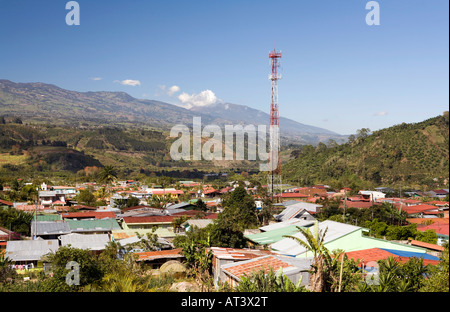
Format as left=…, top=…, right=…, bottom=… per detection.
left=0, top=117, right=258, bottom=178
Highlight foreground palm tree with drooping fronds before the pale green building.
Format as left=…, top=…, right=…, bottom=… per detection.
left=284, top=221, right=340, bottom=292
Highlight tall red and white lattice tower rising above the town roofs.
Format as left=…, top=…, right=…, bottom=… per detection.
left=268, top=48, right=281, bottom=198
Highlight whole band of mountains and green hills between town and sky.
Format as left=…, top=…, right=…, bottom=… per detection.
left=0, top=80, right=449, bottom=189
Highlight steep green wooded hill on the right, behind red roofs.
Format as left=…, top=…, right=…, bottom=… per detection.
left=282, top=112, right=449, bottom=187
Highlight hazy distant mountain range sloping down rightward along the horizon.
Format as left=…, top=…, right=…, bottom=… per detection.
left=0, top=80, right=347, bottom=144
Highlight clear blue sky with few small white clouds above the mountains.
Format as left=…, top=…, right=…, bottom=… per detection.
left=0, top=0, right=449, bottom=134
